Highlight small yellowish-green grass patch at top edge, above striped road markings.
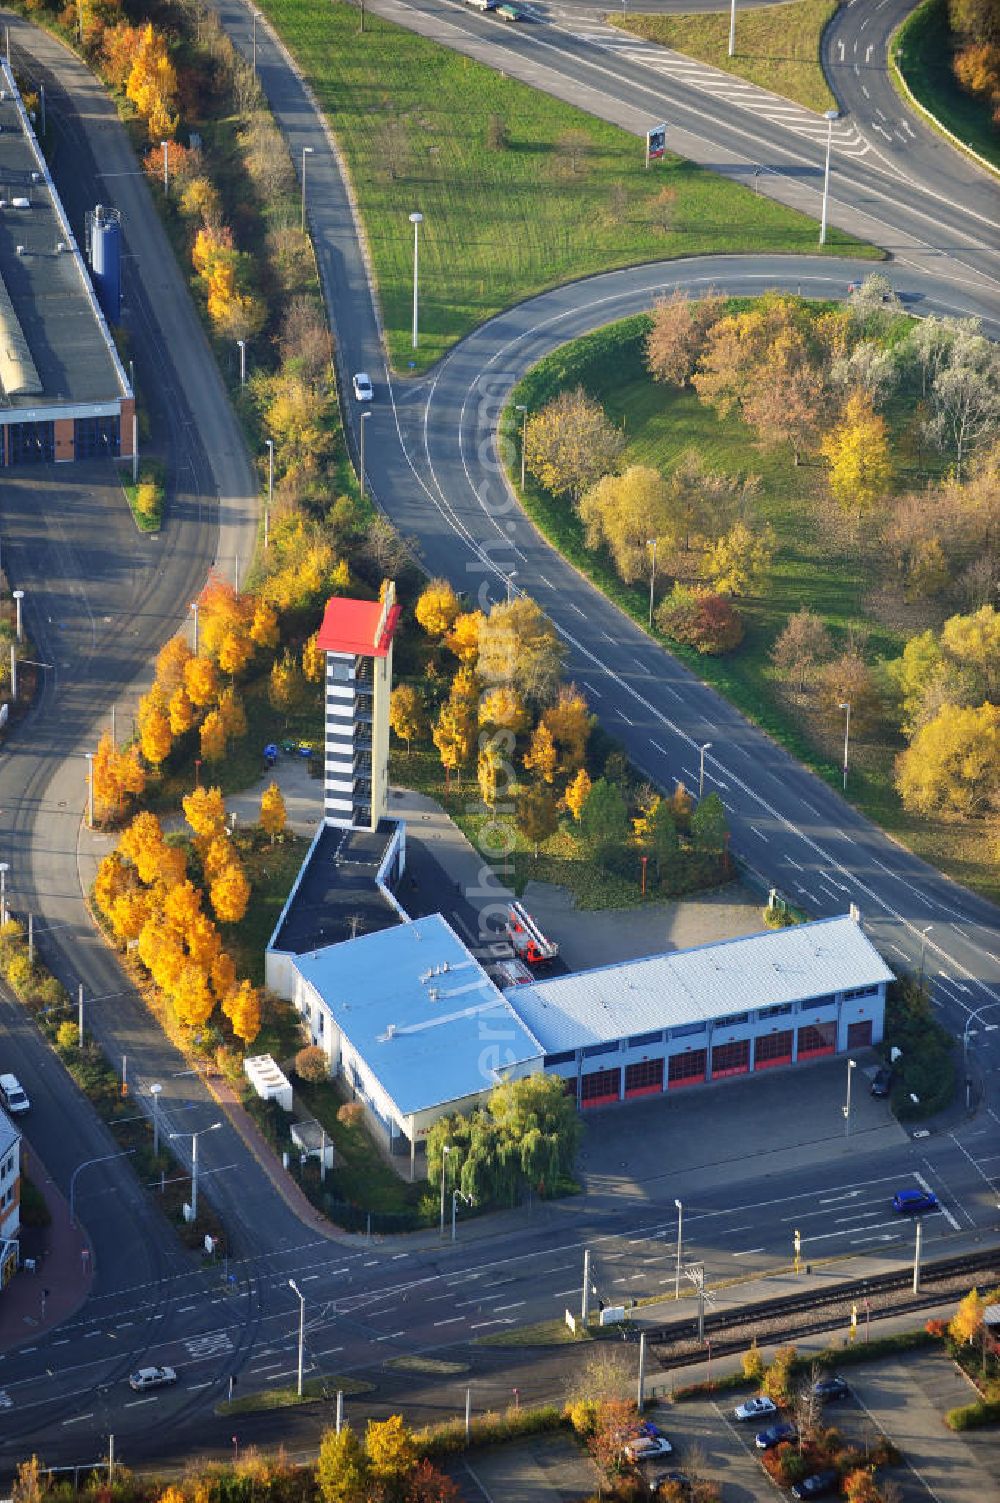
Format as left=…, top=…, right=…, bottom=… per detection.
left=608, top=0, right=839, bottom=114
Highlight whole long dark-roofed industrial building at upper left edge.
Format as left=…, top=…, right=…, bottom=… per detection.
left=0, top=60, right=134, bottom=464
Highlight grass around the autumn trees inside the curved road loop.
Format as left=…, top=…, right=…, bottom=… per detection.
left=504, top=314, right=1000, bottom=900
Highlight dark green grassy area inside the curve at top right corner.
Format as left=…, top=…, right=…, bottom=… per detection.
left=893, top=0, right=1000, bottom=168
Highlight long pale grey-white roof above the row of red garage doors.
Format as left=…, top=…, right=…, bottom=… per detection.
left=505, top=918, right=893, bottom=1054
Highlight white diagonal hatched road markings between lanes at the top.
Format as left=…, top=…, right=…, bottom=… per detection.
left=574, top=29, right=871, bottom=158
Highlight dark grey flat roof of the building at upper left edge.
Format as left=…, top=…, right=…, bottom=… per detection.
left=0, top=65, right=128, bottom=421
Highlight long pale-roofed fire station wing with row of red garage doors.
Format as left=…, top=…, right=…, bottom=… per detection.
left=505, top=918, right=893, bottom=1108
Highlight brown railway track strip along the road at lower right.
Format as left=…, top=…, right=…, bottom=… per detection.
left=647, top=1249, right=1000, bottom=1368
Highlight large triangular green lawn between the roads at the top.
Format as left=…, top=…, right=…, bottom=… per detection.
left=257, top=0, right=878, bottom=370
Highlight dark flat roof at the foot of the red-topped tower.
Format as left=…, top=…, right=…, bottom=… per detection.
left=269, top=819, right=400, bottom=954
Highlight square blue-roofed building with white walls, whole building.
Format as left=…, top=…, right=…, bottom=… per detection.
left=284, top=914, right=543, bottom=1163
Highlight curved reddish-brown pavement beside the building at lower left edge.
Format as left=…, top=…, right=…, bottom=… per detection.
left=0, top=1147, right=93, bottom=1351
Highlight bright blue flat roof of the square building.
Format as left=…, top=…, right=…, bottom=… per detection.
left=295, top=914, right=543, bottom=1115
